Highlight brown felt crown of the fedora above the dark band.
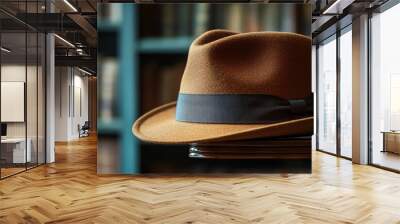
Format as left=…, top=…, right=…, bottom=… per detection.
left=180, top=30, right=311, bottom=99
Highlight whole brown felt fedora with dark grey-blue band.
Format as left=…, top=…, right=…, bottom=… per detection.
left=132, top=30, right=313, bottom=144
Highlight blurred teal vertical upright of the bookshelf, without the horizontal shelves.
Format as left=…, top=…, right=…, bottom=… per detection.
left=118, top=3, right=140, bottom=174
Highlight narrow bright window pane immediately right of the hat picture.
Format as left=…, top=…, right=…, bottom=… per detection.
left=317, top=37, right=336, bottom=153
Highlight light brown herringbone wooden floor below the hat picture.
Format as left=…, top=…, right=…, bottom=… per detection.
left=0, top=138, right=400, bottom=224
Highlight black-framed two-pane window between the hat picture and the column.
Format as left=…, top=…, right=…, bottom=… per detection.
left=316, top=25, right=352, bottom=159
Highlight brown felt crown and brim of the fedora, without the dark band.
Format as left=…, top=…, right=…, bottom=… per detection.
left=132, top=30, right=313, bottom=144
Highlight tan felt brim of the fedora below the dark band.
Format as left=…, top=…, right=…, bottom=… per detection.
left=132, top=102, right=313, bottom=144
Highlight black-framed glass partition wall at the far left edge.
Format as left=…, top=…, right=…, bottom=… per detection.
left=0, top=2, right=46, bottom=179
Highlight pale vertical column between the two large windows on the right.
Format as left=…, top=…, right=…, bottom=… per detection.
left=352, top=15, right=368, bottom=164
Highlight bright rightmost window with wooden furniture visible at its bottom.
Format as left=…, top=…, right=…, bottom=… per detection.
left=371, top=4, right=400, bottom=170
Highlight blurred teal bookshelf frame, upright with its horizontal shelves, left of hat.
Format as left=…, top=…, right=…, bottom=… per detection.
left=98, top=3, right=197, bottom=174
